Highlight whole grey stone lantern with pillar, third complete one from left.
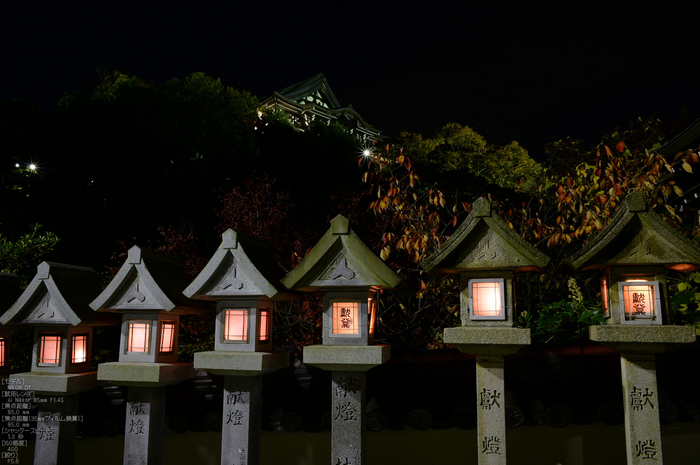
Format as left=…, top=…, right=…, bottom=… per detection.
left=183, top=229, right=295, bottom=465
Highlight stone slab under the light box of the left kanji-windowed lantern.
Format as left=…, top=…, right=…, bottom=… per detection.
left=304, top=345, right=391, bottom=372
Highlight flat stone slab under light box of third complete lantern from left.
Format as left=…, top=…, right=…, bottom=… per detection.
left=194, top=351, right=289, bottom=376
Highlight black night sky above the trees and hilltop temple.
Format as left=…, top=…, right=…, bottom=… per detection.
left=0, top=0, right=700, bottom=156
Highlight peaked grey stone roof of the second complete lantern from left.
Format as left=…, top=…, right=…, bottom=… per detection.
left=90, top=246, right=209, bottom=314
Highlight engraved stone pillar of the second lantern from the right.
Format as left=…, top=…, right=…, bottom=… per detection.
left=476, top=355, right=506, bottom=465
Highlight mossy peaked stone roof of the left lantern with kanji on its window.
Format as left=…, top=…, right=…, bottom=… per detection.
left=282, top=215, right=402, bottom=292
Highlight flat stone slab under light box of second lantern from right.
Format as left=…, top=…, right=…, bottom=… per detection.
left=443, top=326, right=530, bottom=355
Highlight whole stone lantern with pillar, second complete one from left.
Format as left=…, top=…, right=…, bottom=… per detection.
left=90, top=246, right=208, bottom=465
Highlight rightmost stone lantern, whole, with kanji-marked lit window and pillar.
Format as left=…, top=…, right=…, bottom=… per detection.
left=569, top=193, right=700, bottom=465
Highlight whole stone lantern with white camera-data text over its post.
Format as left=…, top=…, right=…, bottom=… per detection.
left=0, top=262, right=118, bottom=464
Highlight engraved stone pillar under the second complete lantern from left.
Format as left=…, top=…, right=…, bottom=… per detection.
left=124, top=386, right=166, bottom=465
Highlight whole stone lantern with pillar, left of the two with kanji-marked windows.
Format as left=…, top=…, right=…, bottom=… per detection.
left=282, top=215, right=401, bottom=465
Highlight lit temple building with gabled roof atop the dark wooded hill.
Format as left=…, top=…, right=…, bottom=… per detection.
left=262, top=73, right=381, bottom=143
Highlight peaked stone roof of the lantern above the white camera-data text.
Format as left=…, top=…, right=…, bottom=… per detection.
left=0, top=262, right=119, bottom=326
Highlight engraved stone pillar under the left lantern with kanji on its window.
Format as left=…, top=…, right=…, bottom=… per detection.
left=331, top=371, right=367, bottom=465
